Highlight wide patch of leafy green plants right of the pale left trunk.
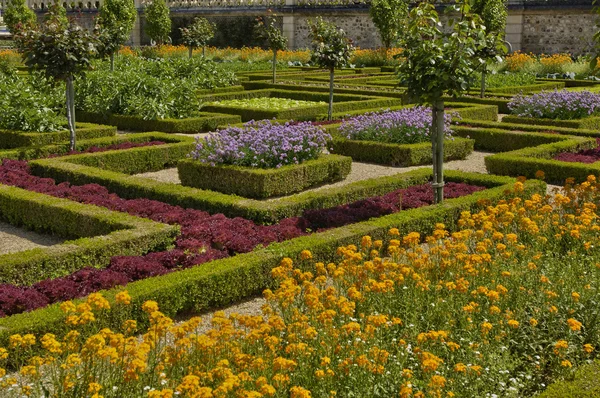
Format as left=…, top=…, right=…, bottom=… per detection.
left=77, top=57, right=236, bottom=120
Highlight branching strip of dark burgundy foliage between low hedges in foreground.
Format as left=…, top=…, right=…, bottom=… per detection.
left=0, top=160, right=485, bottom=316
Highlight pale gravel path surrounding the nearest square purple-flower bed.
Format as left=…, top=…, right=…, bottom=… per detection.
left=136, top=152, right=490, bottom=200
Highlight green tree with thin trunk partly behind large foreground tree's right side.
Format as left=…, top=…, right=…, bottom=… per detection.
left=471, top=0, right=508, bottom=98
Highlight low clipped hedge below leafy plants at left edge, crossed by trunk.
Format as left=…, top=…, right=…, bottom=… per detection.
left=0, top=123, right=117, bottom=149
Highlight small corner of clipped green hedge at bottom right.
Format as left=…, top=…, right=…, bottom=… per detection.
left=538, top=361, right=600, bottom=398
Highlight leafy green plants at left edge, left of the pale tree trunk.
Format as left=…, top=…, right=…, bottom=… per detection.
left=0, top=73, right=66, bottom=132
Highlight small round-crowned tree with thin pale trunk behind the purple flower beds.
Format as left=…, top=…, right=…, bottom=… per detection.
left=309, top=17, right=354, bottom=120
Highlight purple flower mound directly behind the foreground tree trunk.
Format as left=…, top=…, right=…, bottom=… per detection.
left=339, top=106, right=451, bottom=144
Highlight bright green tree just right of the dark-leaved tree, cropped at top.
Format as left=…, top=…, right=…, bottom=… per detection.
left=97, top=0, right=137, bottom=71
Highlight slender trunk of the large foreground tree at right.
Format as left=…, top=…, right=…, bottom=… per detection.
left=431, top=100, right=444, bottom=204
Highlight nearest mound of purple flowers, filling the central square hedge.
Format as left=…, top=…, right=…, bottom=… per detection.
left=190, top=120, right=331, bottom=169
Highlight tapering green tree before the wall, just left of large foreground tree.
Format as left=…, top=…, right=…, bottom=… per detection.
left=369, top=0, right=409, bottom=59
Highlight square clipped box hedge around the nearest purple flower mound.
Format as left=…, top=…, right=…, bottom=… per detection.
left=177, top=155, right=352, bottom=199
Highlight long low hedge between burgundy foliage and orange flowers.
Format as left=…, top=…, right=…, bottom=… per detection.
left=0, top=171, right=546, bottom=366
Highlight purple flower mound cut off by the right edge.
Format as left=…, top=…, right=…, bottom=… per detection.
left=508, top=90, right=600, bottom=120
